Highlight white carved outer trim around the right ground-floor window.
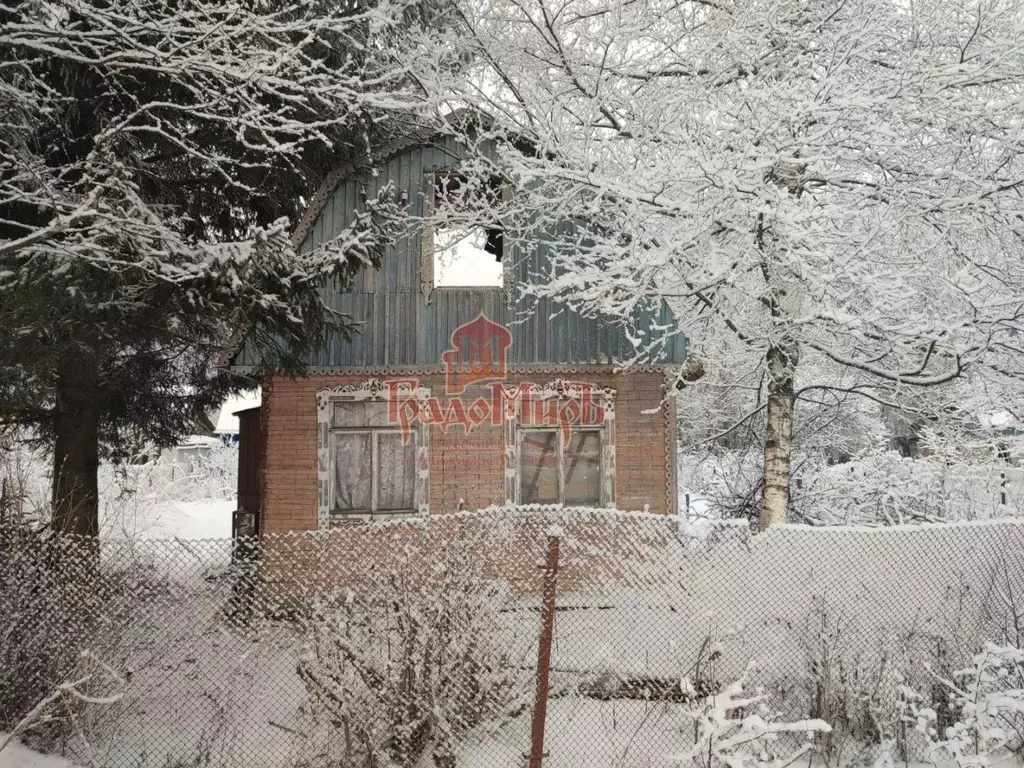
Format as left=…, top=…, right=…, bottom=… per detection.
left=502, top=379, right=615, bottom=509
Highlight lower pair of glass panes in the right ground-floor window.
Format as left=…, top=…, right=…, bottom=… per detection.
left=519, top=429, right=602, bottom=507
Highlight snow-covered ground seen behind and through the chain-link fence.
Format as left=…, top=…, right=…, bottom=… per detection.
left=6, top=434, right=1024, bottom=768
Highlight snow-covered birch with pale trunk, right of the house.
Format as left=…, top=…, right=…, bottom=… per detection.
left=438, top=0, right=1024, bottom=526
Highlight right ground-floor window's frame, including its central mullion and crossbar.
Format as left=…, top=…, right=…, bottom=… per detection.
left=503, top=379, right=615, bottom=508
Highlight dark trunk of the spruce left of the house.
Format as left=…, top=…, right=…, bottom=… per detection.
left=51, top=355, right=99, bottom=537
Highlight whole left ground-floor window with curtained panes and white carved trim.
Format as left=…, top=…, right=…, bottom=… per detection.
left=316, top=379, right=429, bottom=527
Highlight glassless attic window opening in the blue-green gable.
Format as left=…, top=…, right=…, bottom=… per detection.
left=429, top=172, right=505, bottom=288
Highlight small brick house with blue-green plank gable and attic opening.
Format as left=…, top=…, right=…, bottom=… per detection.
left=232, top=126, right=686, bottom=531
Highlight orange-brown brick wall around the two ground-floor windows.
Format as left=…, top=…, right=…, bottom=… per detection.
left=261, top=372, right=675, bottom=532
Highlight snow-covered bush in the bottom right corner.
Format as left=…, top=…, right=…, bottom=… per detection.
left=905, top=643, right=1024, bottom=768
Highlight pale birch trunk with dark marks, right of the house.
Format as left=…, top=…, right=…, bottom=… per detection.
left=761, top=343, right=800, bottom=530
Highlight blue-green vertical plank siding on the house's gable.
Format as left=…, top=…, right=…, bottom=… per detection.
left=236, top=138, right=686, bottom=369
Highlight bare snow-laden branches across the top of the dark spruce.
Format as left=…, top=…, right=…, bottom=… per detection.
left=0, top=0, right=434, bottom=276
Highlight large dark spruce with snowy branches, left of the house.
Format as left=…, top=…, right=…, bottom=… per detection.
left=0, top=0, right=448, bottom=535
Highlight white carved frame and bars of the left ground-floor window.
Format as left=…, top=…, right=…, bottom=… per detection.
left=316, top=379, right=430, bottom=529
